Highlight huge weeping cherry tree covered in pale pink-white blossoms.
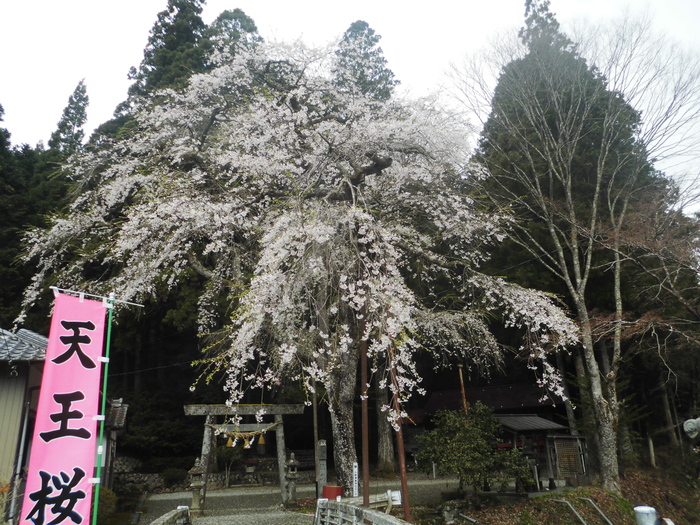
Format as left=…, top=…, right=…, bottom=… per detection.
left=19, top=40, right=578, bottom=486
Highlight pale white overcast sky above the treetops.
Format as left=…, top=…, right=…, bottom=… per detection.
left=0, top=0, right=700, bottom=146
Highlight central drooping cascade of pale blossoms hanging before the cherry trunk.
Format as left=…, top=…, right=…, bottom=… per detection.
left=221, top=202, right=419, bottom=418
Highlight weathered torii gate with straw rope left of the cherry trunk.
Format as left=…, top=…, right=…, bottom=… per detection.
left=185, top=404, right=304, bottom=504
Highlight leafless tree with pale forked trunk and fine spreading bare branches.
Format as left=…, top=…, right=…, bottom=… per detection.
left=453, top=1, right=700, bottom=492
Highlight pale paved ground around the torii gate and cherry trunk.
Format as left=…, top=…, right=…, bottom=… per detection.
left=138, top=477, right=458, bottom=525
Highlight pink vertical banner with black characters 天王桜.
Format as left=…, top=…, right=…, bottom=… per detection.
left=21, top=294, right=106, bottom=525
